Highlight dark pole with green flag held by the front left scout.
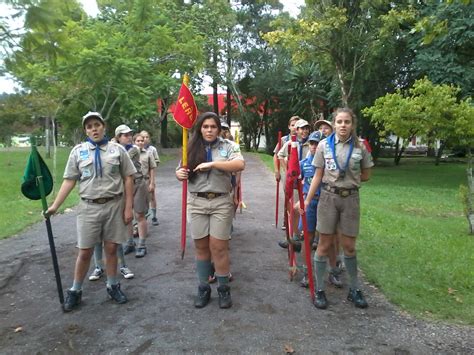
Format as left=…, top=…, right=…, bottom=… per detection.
left=21, top=137, right=64, bottom=304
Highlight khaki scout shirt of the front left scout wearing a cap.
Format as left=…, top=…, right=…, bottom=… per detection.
left=63, top=142, right=136, bottom=199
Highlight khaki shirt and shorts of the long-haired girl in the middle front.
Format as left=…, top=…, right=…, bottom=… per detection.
left=188, top=137, right=244, bottom=240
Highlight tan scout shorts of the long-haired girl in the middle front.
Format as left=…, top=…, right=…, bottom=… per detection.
left=188, top=194, right=234, bottom=240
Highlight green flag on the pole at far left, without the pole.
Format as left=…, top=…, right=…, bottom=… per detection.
left=21, top=147, right=53, bottom=200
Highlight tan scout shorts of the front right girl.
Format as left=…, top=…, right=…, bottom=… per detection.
left=316, top=190, right=360, bottom=237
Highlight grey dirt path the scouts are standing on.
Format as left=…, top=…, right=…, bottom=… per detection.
left=0, top=155, right=474, bottom=354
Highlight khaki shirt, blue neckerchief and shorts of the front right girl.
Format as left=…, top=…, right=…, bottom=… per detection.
left=313, top=133, right=374, bottom=237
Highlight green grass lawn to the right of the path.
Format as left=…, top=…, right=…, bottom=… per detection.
left=259, top=154, right=474, bottom=325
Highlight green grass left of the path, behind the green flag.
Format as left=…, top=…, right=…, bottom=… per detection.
left=0, top=147, right=173, bottom=239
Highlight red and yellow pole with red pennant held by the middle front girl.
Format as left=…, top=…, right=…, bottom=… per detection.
left=173, top=74, right=197, bottom=259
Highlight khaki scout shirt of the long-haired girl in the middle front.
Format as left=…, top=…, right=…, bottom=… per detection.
left=188, top=137, right=244, bottom=193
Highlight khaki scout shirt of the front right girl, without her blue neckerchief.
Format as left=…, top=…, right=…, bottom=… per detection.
left=313, top=135, right=374, bottom=189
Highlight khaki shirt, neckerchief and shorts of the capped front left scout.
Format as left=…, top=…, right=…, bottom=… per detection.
left=63, top=142, right=136, bottom=249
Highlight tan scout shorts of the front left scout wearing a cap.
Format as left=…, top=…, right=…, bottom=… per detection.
left=77, top=196, right=128, bottom=249
